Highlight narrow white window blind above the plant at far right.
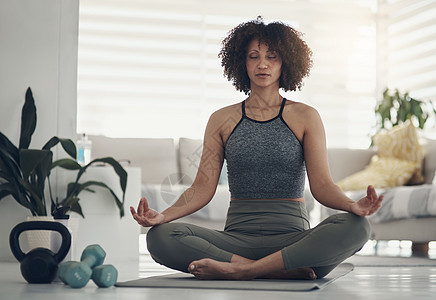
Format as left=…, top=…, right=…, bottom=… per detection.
left=378, top=0, right=436, bottom=127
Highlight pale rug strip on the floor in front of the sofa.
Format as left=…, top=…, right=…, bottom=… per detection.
left=345, top=255, right=436, bottom=267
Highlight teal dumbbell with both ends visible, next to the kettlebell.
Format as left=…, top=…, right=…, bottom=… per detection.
left=59, top=245, right=106, bottom=288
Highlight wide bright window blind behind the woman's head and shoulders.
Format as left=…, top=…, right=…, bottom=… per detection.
left=77, top=0, right=376, bottom=147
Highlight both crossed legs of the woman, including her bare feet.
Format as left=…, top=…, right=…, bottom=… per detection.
left=147, top=213, right=370, bottom=280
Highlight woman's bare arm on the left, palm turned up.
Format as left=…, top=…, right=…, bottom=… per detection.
left=130, top=111, right=224, bottom=227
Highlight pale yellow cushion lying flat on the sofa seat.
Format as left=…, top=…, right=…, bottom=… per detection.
left=338, top=155, right=417, bottom=191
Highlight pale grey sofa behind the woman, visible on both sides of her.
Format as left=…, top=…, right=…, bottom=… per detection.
left=89, top=136, right=436, bottom=250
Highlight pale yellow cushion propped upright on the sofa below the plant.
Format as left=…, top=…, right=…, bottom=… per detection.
left=374, top=121, right=424, bottom=184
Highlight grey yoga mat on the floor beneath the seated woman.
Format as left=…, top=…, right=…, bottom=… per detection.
left=115, top=263, right=354, bottom=291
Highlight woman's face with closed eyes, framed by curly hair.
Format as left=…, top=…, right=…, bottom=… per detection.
left=246, top=39, right=282, bottom=89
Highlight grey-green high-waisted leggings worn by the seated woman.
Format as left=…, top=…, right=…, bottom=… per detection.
left=147, top=200, right=370, bottom=278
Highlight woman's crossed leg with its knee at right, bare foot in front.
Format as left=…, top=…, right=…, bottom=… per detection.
left=188, top=213, right=370, bottom=280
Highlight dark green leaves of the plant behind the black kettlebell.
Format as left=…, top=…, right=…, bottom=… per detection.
left=0, top=88, right=127, bottom=219
